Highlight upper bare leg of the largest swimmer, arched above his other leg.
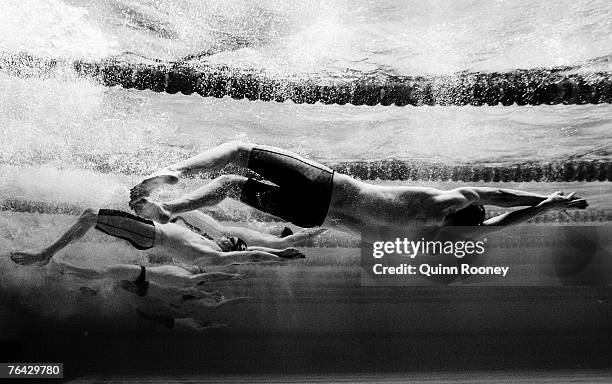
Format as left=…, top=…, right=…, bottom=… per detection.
left=130, top=141, right=253, bottom=201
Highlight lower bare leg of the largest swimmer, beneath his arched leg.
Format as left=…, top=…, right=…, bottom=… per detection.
left=130, top=175, right=247, bottom=224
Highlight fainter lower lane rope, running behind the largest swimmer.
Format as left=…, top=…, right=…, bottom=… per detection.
left=0, top=157, right=612, bottom=183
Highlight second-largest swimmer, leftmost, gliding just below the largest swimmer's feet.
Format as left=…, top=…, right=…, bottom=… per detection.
left=10, top=209, right=317, bottom=265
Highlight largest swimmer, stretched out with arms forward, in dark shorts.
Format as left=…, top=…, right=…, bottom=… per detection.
left=130, top=142, right=588, bottom=235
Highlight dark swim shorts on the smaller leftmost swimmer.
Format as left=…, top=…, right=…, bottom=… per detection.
left=96, top=209, right=155, bottom=250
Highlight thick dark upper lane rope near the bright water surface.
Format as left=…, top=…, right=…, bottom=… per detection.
left=0, top=53, right=612, bottom=106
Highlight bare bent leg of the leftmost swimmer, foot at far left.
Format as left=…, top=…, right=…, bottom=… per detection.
left=11, top=209, right=98, bottom=265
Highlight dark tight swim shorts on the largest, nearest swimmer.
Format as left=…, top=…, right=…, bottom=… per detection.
left=240, top=146, right=334, bottom=228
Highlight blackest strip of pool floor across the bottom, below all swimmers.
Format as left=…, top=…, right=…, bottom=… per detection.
left=2, top=330, right=612, bottom=380
